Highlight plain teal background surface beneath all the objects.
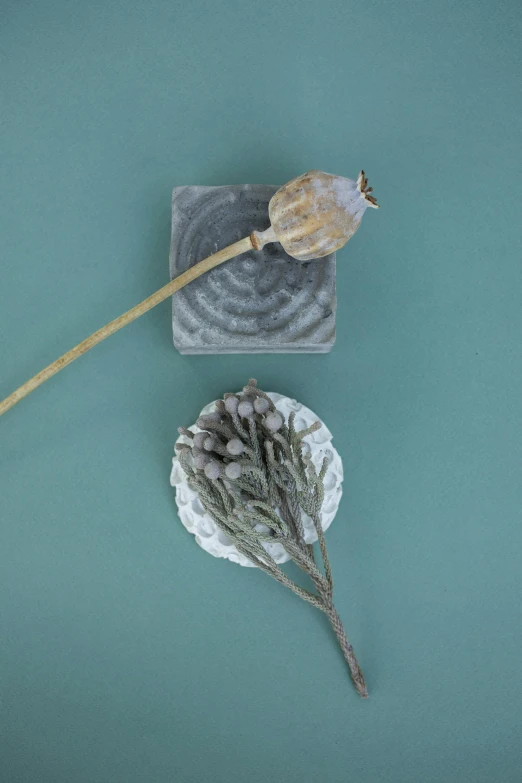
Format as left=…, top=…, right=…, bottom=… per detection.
left=0, top=0, right=522, bottom=783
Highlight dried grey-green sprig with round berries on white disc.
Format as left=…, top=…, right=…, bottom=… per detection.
left=176, top=379, right=368, bottom=698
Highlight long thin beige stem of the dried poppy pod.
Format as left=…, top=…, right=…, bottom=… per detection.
left=0, top=231, right=268, bottom=416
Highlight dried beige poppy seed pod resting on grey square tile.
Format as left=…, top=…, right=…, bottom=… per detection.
left=260, top=170, right=378, bottom=261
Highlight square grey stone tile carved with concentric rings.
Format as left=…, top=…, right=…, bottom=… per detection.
left=170, top=185, right=336, bottom=354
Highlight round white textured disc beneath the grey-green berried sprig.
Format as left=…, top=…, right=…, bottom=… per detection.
left=170, top=392, right=343, bottom=567
